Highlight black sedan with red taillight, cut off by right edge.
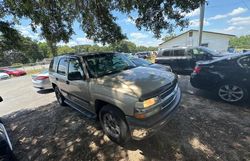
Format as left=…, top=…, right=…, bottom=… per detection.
left=190, top=52, right=250, bottom=103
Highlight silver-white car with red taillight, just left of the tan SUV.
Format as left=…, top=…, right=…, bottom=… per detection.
left=31, top=69, right=52, bottom=90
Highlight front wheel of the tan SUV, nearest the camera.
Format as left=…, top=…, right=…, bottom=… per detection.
left=99, top=105, right=131, bottom=145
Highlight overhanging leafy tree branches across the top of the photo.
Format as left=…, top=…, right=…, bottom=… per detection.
left=0, top=0, right=205, bottom=55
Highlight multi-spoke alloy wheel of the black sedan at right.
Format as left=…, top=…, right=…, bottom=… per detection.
left=217, top=82, right=248, bottom=103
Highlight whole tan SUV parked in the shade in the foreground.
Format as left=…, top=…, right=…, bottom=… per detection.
left=49, top=53, right=181, bottom=144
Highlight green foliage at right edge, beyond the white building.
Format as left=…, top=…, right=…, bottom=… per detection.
left=229, top=35, right=250, bottom=49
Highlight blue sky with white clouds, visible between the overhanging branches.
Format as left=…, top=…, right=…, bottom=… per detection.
left=12, top=0, right=250, bottom=46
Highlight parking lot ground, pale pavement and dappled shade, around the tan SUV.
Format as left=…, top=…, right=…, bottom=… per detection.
left=0, top=76, right=250, bottom=161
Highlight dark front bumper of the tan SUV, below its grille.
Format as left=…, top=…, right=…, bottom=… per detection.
left=126, top=87, right=181, bottom=140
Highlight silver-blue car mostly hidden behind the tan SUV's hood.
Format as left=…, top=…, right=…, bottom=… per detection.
left=125, top=54, right=172, bottom=72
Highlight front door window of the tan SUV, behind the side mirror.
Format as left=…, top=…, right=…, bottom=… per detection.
left=68, top=58, right=84, bottom=80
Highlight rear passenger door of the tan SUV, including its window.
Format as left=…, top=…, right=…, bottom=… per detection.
left=55, top=57, right=68, bottom=98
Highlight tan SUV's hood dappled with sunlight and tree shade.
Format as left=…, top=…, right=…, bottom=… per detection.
left=99, top=67, right=176, bottom=98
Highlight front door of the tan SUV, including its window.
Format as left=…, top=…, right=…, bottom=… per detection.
left=67, top=57, right=93, bottom=112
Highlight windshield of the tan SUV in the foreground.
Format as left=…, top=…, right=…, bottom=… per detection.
left=86, top=53, right=136, bottom=77
